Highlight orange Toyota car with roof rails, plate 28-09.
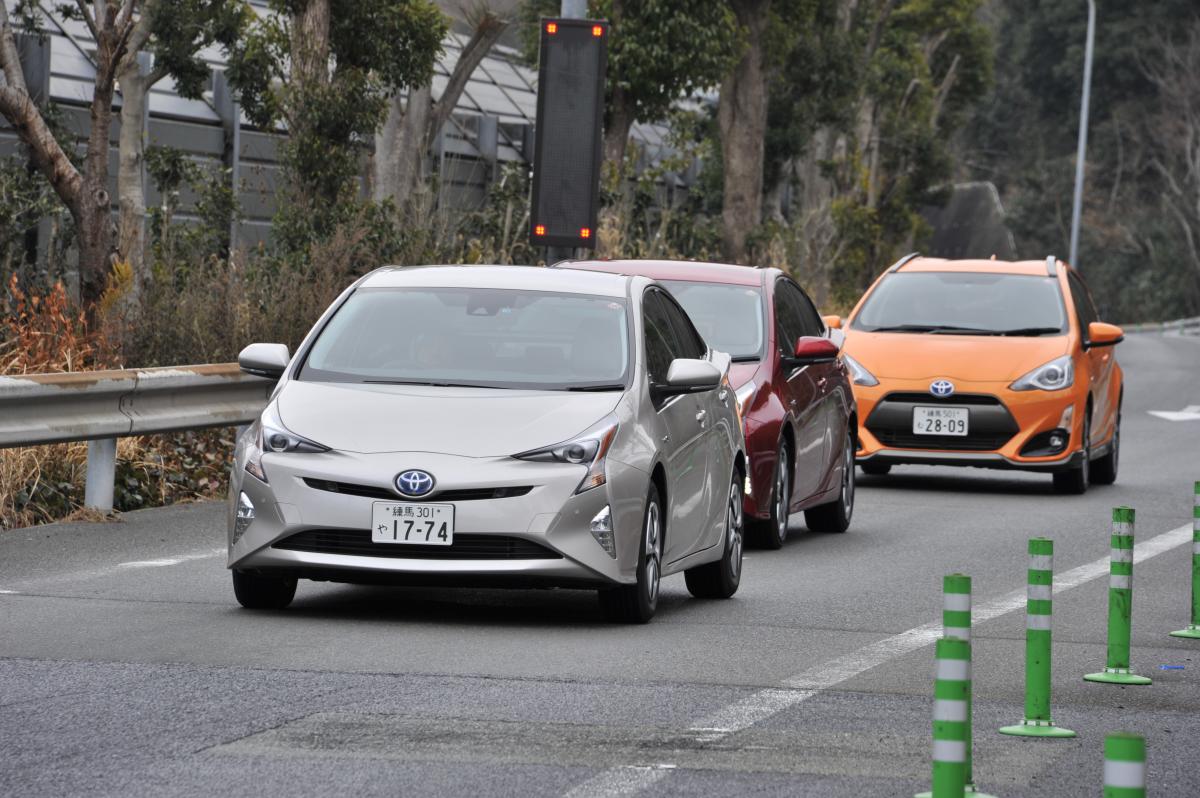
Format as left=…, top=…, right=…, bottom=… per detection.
left=826, top=254, right=1124, bottom=493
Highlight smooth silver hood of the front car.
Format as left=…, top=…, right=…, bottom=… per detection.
left=275, top=380, right=623, bottom=457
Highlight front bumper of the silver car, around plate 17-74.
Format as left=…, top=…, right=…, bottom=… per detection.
left=227, top=442, right=649, bottom=586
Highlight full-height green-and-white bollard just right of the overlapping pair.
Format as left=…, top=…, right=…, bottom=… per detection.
left=1000, top=538, right=1075, bottom=737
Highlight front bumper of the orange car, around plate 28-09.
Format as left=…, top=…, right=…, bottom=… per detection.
left=854, top=378, right=1087, bottom=472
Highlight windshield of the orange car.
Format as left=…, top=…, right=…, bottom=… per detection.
left=851, top=271, right=1067, bottom=336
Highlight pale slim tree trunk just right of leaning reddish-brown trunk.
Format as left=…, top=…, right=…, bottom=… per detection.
left=116, top=58, right=150, bottom=295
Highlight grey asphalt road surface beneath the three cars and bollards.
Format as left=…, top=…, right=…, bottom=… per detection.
left=0, top=336, right=1200, bottom=798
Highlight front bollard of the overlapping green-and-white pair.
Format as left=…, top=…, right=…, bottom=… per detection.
left=930, top=637, right=971, bottom=798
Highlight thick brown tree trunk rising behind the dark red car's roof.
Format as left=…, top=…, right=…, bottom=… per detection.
left=716, top=0, right=770, bottom=263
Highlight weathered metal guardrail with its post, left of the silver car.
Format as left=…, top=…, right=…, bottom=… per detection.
left=0, top=364, right=275, bottom=512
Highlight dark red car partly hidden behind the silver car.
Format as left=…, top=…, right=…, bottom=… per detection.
left=562, top=260, right=858, bottom=548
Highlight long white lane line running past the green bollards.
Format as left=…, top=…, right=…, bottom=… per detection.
left=564, top=523, right=1192, bottom=798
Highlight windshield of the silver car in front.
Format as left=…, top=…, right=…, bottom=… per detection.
left=299, top=288, right=630, bottom=390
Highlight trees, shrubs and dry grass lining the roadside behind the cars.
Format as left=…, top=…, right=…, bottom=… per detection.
left=0, top=0, right=1200, bottom=527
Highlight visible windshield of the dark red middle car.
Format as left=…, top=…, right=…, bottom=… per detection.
left=661, top=280, right=763, bottom=360
